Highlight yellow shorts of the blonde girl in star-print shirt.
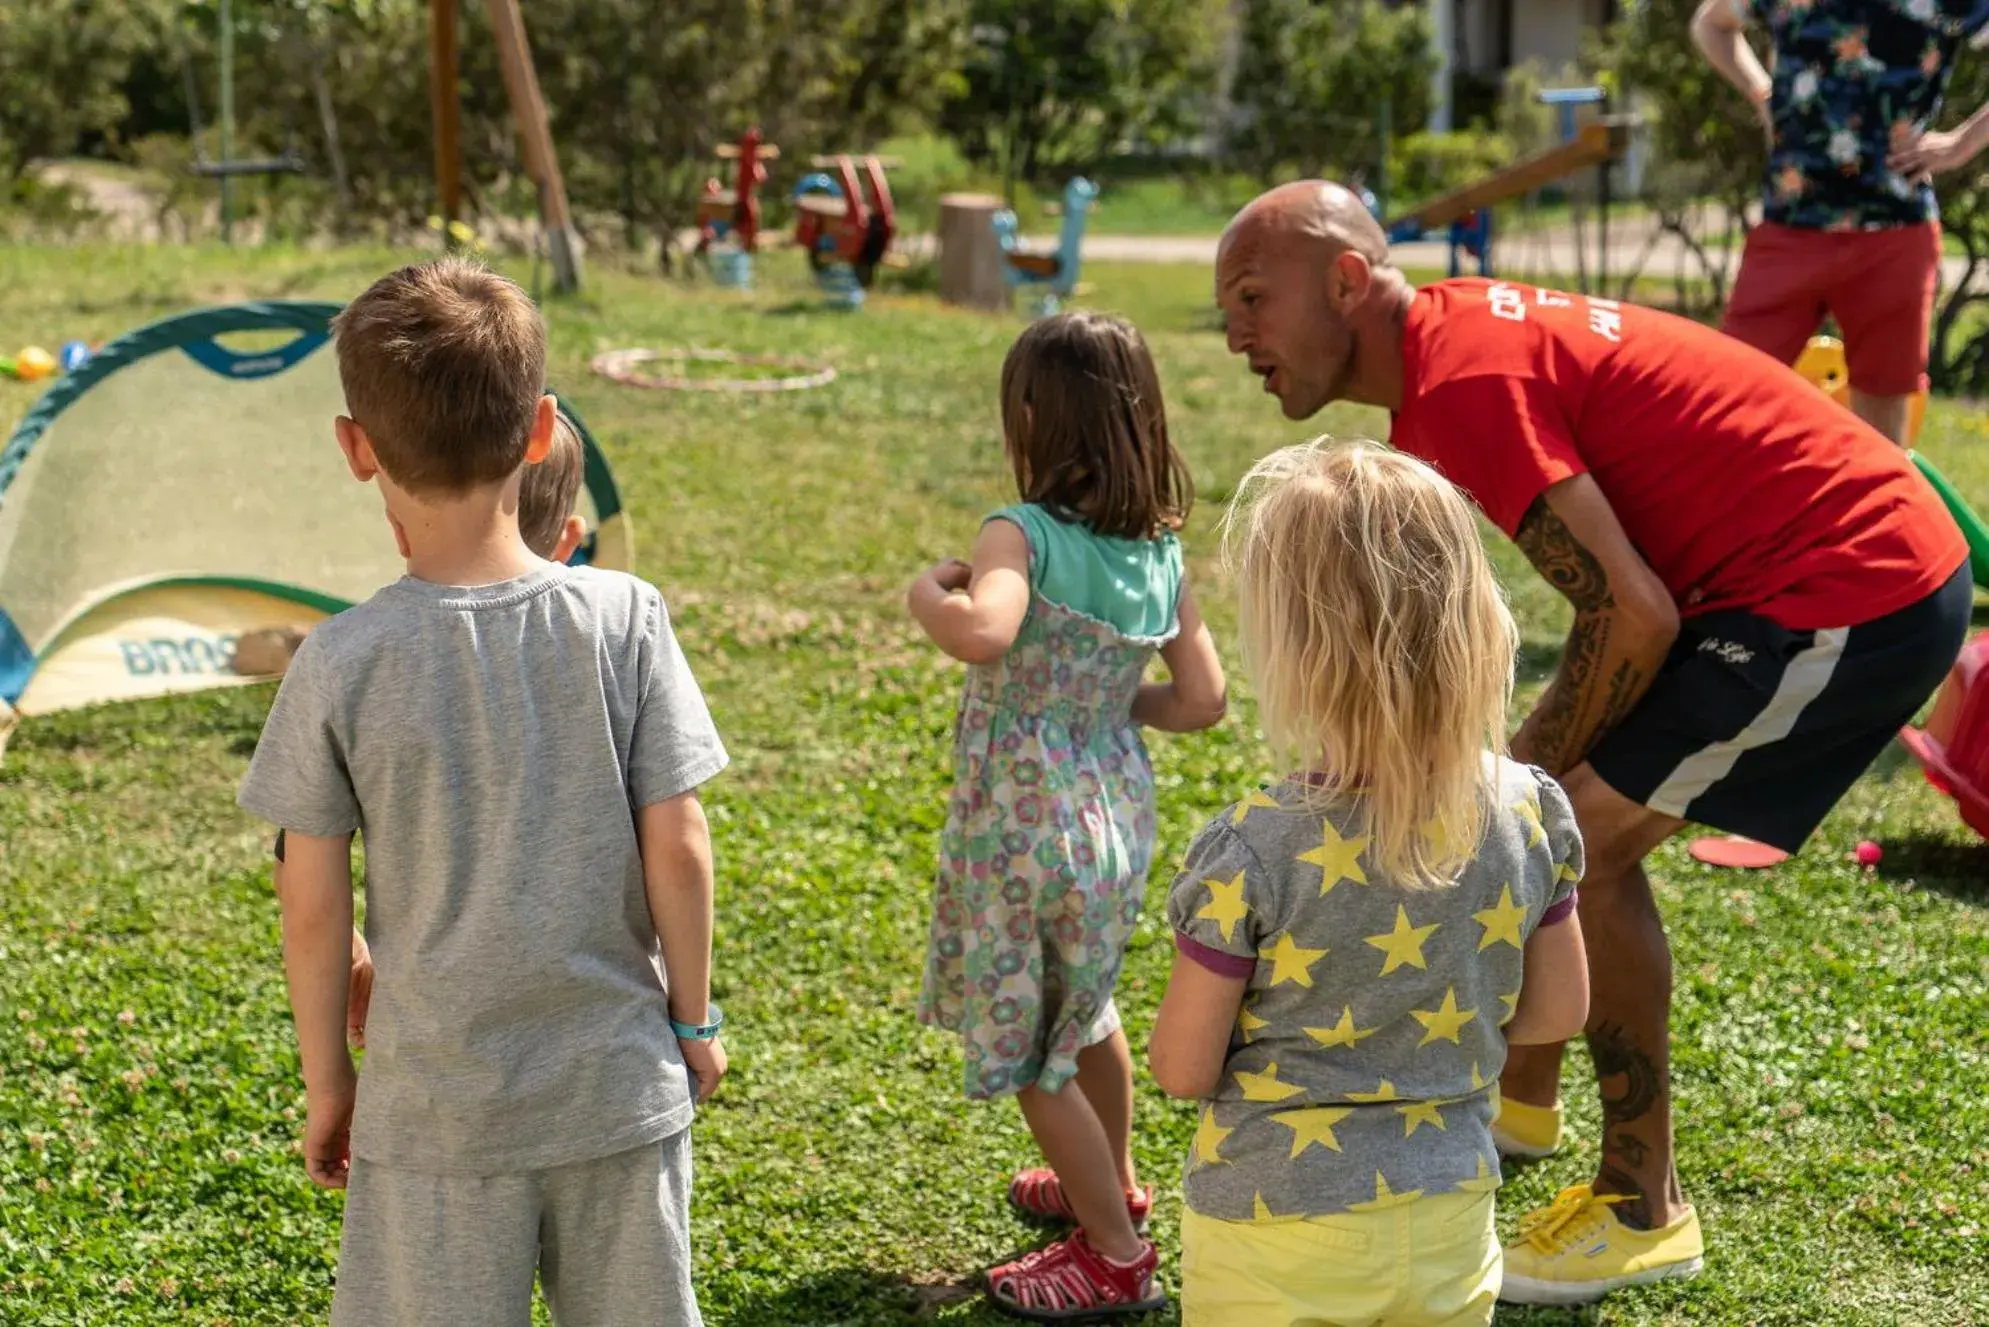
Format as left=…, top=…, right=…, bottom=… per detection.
left=1181, top=1194, right=1502, bottom=1327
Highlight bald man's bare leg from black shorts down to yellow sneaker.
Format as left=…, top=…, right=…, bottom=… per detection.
left=1551, top=764, right=1685, bottom=1230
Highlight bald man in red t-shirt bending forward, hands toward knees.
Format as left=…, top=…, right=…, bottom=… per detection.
left=1215, top=181, right=1973, bottom=1303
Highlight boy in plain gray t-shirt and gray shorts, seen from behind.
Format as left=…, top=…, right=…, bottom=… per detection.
left=239, top=259, right=726, bottom=1327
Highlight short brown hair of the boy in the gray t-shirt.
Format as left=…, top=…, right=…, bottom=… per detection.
left=332, top=257, right=545, bottom=493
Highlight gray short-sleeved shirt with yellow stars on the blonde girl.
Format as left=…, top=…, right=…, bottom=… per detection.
left=1168, top=758, right=1583, bottom=1222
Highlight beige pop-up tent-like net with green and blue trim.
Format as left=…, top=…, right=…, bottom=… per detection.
left=0, top=300, right=631, bottom=748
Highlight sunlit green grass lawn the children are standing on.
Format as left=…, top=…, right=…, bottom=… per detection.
left=0, top=249, right=1989, bottom=1327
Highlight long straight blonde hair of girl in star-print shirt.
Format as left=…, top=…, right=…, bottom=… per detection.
left=1223, top=438, right=1518, bottom=889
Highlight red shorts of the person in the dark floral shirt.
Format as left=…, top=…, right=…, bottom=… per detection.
left=1720, top=221, right=1941, bottom=396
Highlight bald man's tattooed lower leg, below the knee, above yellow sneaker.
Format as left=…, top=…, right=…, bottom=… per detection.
left=1581, top=865, right=1685, bottom=1230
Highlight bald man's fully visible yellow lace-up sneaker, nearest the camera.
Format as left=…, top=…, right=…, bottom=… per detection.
left=1498, top=1184, right=1707, bottom=1305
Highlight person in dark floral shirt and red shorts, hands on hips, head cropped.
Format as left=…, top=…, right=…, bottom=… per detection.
left=1693, top=0, right=1989, bottom=446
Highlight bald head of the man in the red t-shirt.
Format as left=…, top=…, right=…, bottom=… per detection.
left=1215, top=179, right=1408, bottom=420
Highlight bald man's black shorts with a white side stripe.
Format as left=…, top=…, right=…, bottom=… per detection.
left=1589, top=563, right=1975, bottom=853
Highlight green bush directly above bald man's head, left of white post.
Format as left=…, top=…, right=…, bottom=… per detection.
left=1227, top=0, right=1436, bottom=181
